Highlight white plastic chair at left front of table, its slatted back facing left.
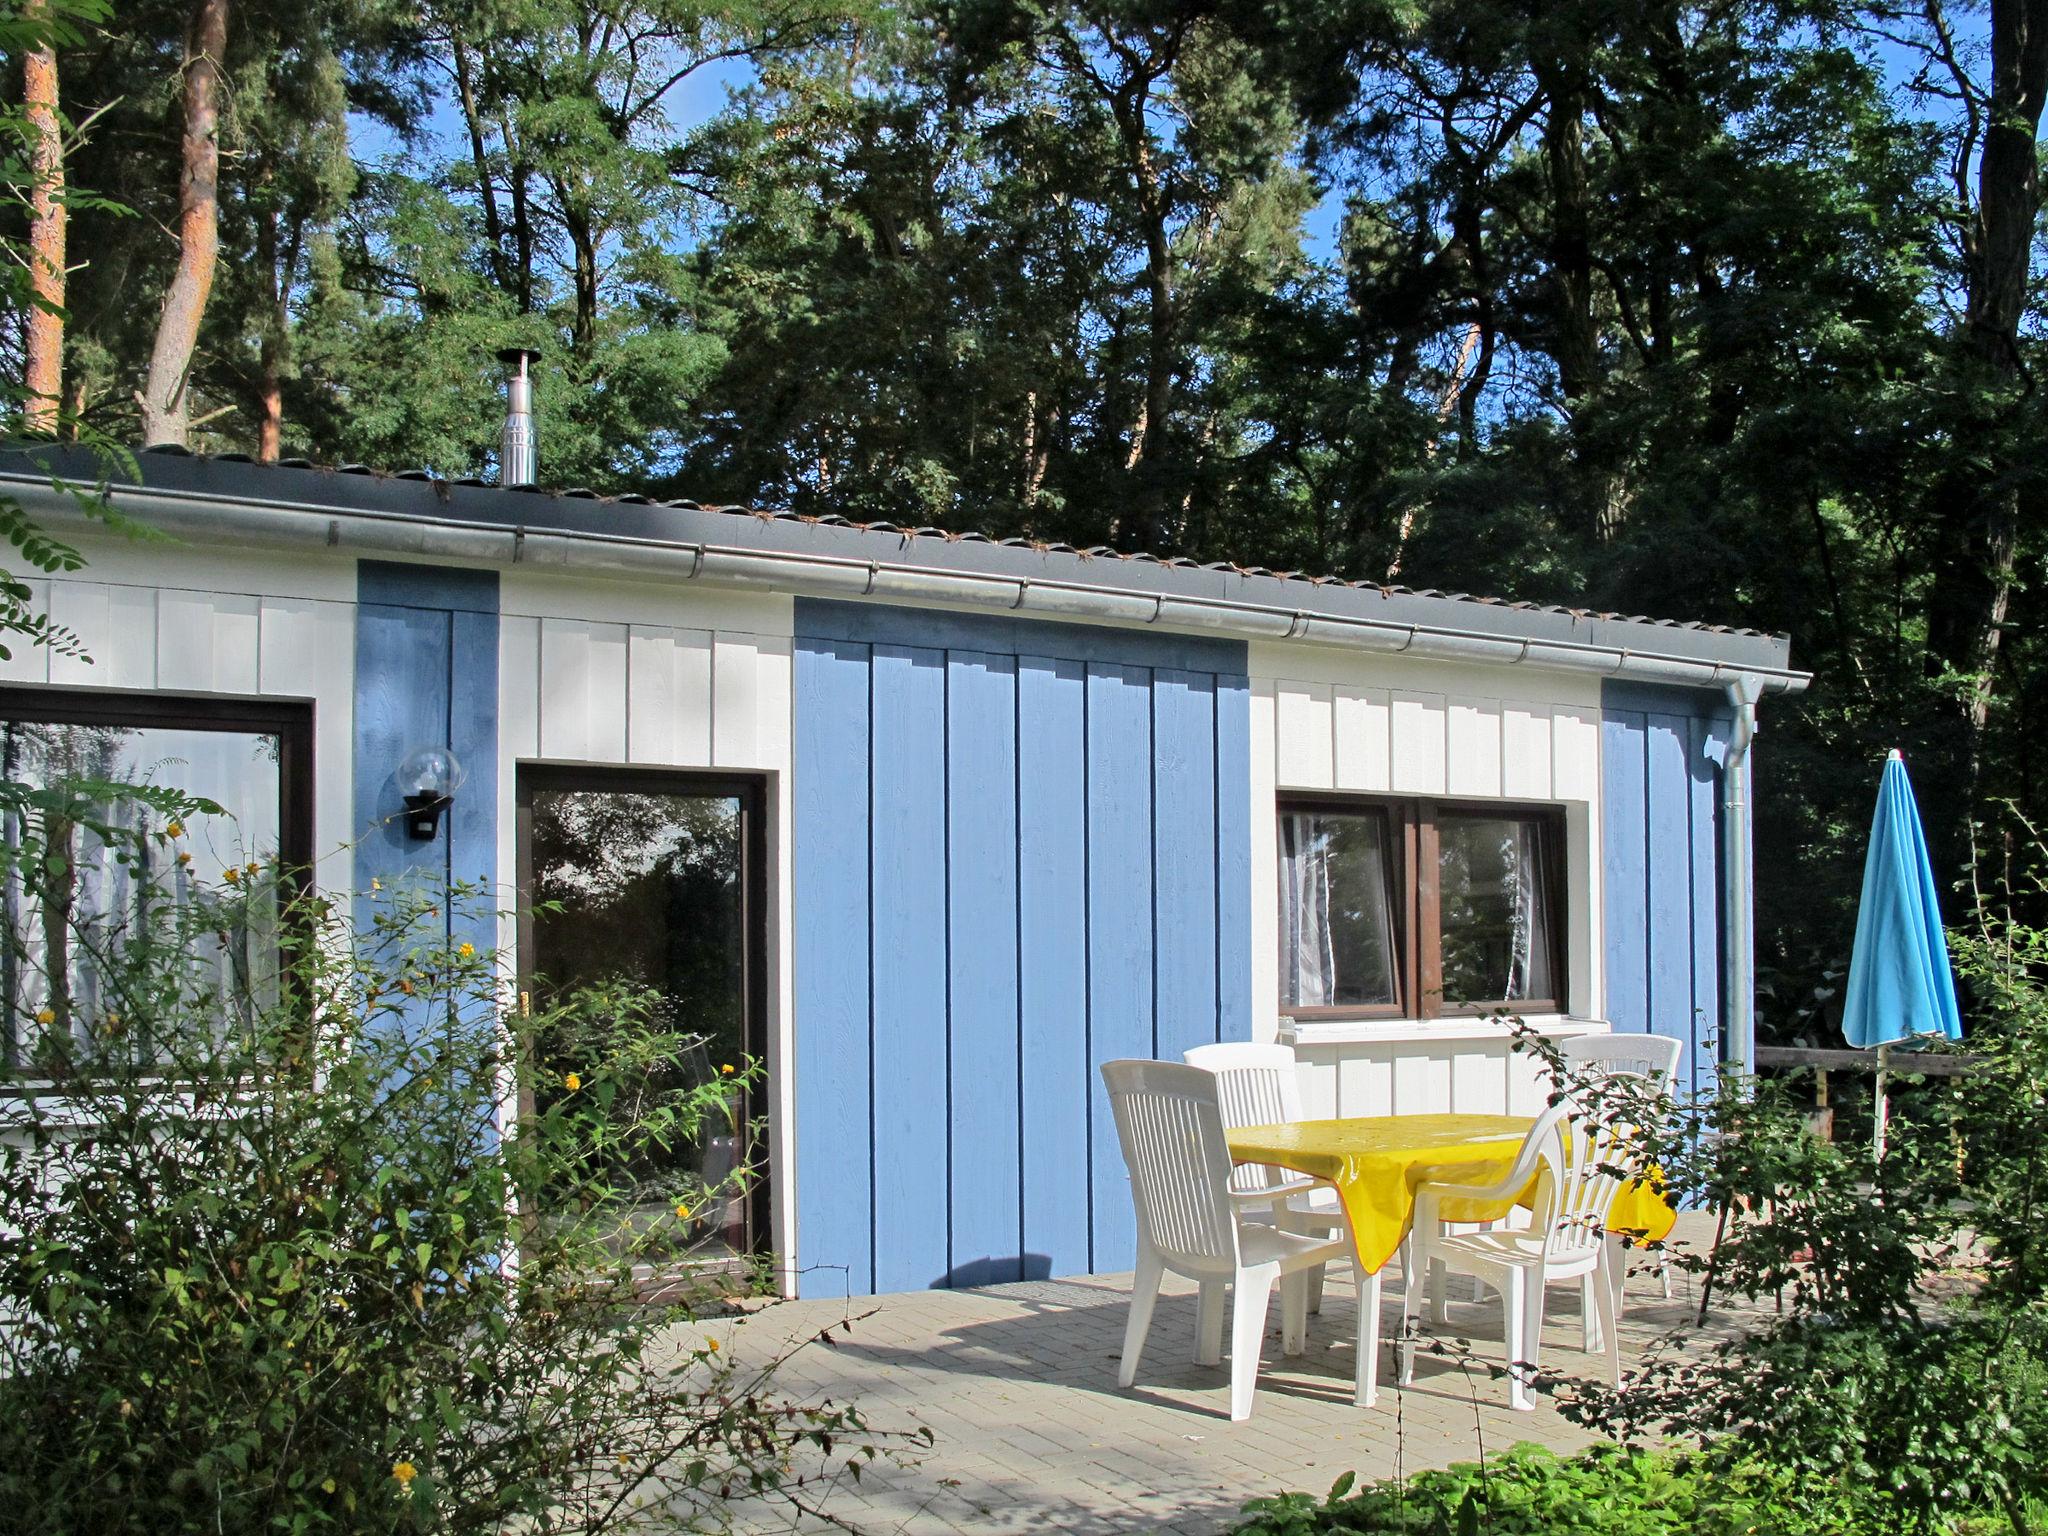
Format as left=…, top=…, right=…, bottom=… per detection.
left=1102, top=1061, right=1350, bottom=1419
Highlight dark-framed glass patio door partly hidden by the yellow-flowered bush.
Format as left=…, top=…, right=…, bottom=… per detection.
left=518, top=766, right=768, bottom=1280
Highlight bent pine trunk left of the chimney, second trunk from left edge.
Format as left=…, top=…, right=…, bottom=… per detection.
left=137, top=0, right=229, bottom=446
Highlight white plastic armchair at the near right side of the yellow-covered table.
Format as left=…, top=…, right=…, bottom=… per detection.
left=1401, top=1100, right=1634, bottom=1409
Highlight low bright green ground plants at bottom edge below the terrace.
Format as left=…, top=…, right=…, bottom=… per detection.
left=1237, top=1446, right=1890, bottom=1536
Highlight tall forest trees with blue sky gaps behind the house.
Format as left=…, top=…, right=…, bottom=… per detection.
left=0, top=0, right=2048, bottom=1038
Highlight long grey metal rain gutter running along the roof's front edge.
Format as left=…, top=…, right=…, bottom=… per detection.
left=16, top=475, right=1808, bottom=692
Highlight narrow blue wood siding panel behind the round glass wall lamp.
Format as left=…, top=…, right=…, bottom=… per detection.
left=352, top=561, right=498, bottom=948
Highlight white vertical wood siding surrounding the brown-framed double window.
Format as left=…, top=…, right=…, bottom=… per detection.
left=1251, top=645, right=1604, bottom=1114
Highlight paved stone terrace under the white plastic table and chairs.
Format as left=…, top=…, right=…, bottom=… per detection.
left=692, top=1221, right=1731, bottom=1536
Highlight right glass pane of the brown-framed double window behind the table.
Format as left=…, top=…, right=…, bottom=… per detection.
left=1438, top=815, right=1556, bottom=1006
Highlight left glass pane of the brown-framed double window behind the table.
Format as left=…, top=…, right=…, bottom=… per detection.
left=1280, top=811, right=1397, bottom=1008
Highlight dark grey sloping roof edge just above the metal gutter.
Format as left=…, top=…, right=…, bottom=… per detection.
left=0, top=444, right=1804, bottom=688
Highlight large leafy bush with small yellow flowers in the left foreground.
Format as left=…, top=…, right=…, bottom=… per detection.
left=0, top=879, right=913, bottom=1532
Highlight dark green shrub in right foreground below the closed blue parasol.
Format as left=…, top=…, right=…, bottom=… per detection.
left=1507, top=868, right=2048, bottom=1532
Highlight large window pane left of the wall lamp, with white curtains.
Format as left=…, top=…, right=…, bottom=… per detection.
left=0, top=719, right=283, bottom=1073
